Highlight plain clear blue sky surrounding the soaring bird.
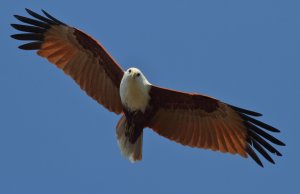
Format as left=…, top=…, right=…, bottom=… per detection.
left=0, top=0, right=300, bottom=194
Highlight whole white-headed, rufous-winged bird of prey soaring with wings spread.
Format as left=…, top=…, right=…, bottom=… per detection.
left=11, top=9, right=285, bottom=167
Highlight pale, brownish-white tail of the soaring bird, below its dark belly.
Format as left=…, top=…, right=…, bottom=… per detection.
left=116, top=115, right=143, bottom=162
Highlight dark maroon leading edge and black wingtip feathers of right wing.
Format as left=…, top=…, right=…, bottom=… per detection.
left=150, top=85, right=285, bottom=167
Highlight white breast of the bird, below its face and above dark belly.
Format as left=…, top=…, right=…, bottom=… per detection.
left=120, top=75, right=151, bottom=112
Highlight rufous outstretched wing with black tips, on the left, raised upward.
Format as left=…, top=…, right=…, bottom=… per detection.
left=11, top=9, right=124, bottom=114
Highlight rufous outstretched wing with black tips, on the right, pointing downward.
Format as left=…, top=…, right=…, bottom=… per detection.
left=149, top=86, right=284, bottom=166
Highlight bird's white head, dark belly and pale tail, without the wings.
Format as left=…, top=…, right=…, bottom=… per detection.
left=117, top=67, right=151, bottom=162
